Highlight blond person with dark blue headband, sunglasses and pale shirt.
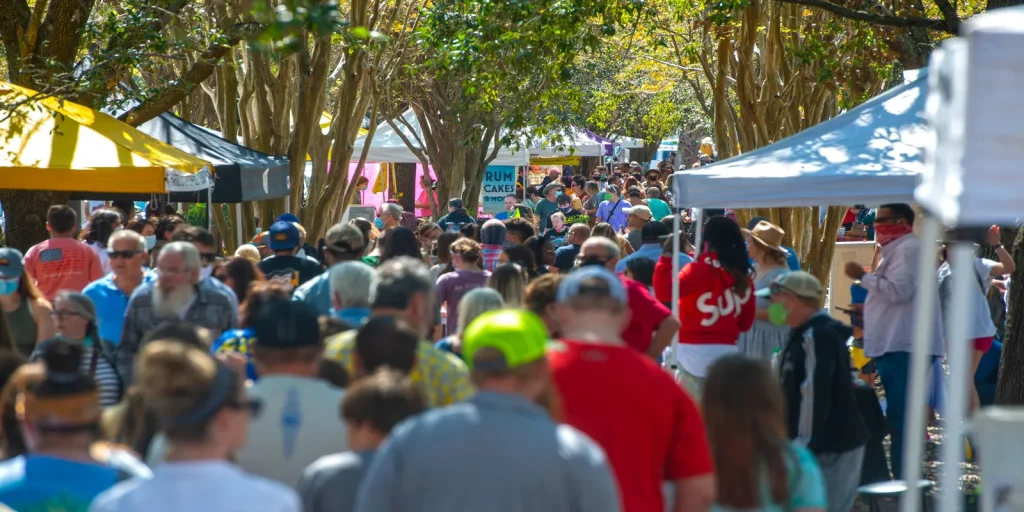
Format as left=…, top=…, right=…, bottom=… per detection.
left=89, top=339, right=302, bottom=512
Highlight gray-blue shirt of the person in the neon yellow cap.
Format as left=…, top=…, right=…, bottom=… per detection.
left=355, top=391, right=621, bottom=512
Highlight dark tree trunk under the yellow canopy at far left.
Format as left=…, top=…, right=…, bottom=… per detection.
left=0, top=190, right=66, bottom=249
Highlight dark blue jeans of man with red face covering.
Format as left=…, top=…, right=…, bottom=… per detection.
left=873, top=352, right=938, bottom=479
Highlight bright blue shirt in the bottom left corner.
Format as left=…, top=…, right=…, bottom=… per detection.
left=0, top=455, right=122, bottom=512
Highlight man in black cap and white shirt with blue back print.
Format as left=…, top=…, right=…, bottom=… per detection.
left=239, top=300, right=348, bottom=487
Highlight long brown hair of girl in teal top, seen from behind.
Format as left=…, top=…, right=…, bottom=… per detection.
left=701, top=355, right=800, bottom=509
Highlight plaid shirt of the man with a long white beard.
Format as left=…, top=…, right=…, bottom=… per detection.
left=118, top=286, right=239, bottom=387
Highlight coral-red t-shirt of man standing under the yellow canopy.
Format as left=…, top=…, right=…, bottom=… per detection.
left=25, top=239, right=103, bottom=301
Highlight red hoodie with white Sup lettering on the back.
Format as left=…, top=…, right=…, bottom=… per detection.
left=653, top=253, right=757, bottom=345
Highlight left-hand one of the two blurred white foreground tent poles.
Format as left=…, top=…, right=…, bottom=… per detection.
left=890, top=215, right=937, bottom=512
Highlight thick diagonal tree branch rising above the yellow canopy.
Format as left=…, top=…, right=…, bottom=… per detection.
left=118, top=22, right=263, bottom=126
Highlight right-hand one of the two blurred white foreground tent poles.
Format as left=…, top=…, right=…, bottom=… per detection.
left=939, top=240, right=970, bottom=512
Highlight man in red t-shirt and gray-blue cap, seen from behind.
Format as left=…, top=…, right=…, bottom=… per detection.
left=548, top=268, right=715, bottom=512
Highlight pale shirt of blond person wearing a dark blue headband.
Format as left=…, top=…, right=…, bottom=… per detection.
left=89, top=461, right=302, bottom=512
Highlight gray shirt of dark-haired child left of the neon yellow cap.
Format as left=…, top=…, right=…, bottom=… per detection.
left=298, top=452, right=376, bottom=512
